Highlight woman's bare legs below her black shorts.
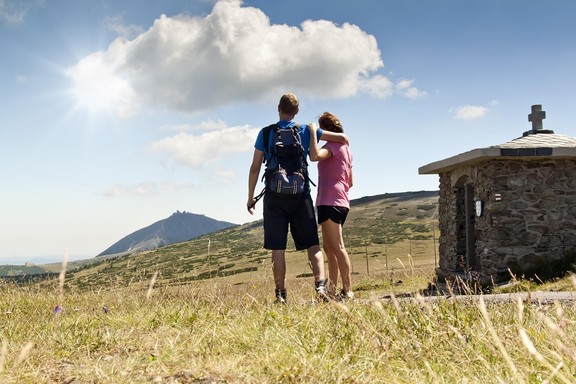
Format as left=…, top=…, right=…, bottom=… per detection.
left=322, top=219, right=352, bottom=292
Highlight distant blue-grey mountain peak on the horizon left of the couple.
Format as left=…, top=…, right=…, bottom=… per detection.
left=98, top=211, right=236, bottom=256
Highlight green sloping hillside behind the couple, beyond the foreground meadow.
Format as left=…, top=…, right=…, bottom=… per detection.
left=56, top=191, right=438, bottom=289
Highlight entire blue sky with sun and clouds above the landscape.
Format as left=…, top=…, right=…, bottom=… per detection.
left=0, top=0, right=576, bottom=264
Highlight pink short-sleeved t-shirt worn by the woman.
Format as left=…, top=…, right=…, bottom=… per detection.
left=316, top=142, right=352, bottom=208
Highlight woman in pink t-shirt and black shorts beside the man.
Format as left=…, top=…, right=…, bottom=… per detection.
left=308, top=112, right=354, bottom=299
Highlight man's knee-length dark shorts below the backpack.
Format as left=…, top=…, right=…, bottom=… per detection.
left=264, top=192, right=320, bottom=251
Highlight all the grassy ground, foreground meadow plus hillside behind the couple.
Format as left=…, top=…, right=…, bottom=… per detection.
left=0, top=196, right=576, bottom=384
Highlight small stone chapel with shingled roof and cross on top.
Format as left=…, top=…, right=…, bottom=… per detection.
left=418, top=105, right=576, bottom=286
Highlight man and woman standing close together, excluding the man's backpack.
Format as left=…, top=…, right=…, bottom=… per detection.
left=247, top=94, right=353, bottom=303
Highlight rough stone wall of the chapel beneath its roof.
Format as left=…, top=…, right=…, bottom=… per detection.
left=438, top=159, right=576, bottom=282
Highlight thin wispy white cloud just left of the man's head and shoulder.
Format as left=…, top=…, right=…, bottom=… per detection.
left=150, top=126, right=259, bottom=168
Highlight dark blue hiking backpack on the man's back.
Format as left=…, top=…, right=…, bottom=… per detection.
left=263, top=124, right=315, bottom=195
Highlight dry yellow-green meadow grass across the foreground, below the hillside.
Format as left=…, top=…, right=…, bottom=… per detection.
left=0, top=269, right=576, bottom=383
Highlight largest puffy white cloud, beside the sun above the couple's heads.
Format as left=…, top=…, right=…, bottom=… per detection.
left=69, top=0, right=393, bottom=114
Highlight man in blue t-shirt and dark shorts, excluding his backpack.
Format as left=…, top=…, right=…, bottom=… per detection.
left=247, top=93, right=347, bottom=303
